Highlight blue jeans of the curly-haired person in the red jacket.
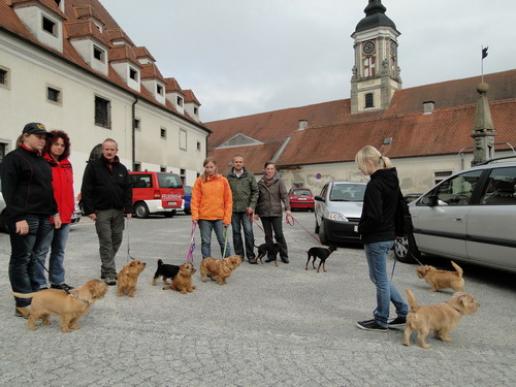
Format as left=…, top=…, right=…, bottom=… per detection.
left=34, top=224, right=70, bottom=289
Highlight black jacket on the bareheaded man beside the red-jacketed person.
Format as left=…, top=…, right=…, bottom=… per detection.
left=81, top=157, right=133, bottom=215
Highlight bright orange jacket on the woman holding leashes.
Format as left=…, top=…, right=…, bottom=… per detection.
left=190, top=175, right=233, bottom=224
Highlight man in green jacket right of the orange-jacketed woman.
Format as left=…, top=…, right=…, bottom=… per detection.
left=228, top=156, right=258, bottom=264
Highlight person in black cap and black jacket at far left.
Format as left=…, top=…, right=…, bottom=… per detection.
left=0, top=123, right=61, bottom=318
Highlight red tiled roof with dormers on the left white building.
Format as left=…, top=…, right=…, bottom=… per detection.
left=0, top=0, right=210, bottom=132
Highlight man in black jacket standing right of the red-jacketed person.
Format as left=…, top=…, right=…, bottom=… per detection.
left=81, top=138, right=132, bottom=285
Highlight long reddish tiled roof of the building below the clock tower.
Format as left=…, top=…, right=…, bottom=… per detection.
left=206, top=70, right=516, bottom=165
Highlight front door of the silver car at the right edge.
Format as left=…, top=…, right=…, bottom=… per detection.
left=411, top=170, right=482, bottom=259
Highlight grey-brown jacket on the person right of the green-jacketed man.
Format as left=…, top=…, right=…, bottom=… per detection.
left=256, top=174, right=290, bottom=217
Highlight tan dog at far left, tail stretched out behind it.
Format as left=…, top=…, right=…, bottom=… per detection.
left=13, top=280, right=107, bottom=332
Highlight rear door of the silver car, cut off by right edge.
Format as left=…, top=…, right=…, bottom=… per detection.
left=466, top=166, right=516, bottom=271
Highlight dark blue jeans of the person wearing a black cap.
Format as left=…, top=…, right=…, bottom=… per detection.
left=9, top=215, right=53, bottom=307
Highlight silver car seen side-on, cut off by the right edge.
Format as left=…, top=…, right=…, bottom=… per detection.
left=394, top=158, right=516, bottom=272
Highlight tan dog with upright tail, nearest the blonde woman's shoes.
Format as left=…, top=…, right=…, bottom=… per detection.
left=403, top=289, right=479, bottom=348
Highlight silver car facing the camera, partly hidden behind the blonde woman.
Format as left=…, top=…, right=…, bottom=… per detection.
left=315, top=181, right=366, bottom=244
